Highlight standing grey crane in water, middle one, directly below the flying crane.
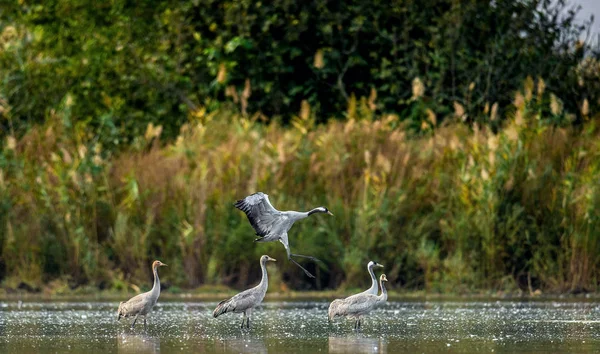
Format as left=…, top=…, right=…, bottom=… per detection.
left=213, top=255, right=276, bottom=328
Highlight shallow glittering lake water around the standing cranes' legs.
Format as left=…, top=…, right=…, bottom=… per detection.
left=0, top=300, right=600, bottom=353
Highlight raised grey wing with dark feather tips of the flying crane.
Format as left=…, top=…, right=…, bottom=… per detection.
left=234, top=192, right=283, bottom=236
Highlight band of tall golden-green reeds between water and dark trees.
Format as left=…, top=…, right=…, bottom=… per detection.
left=0, top=89, right=600, bottom=292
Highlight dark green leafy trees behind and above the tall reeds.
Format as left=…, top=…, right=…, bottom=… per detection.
left=0, top=0, right=600, bottom=150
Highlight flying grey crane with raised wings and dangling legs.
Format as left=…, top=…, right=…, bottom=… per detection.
left=234, top=192, right=333, bottom=278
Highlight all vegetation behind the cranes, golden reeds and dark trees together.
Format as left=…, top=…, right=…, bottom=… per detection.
left=0, top=0, right=600, bottom=293
